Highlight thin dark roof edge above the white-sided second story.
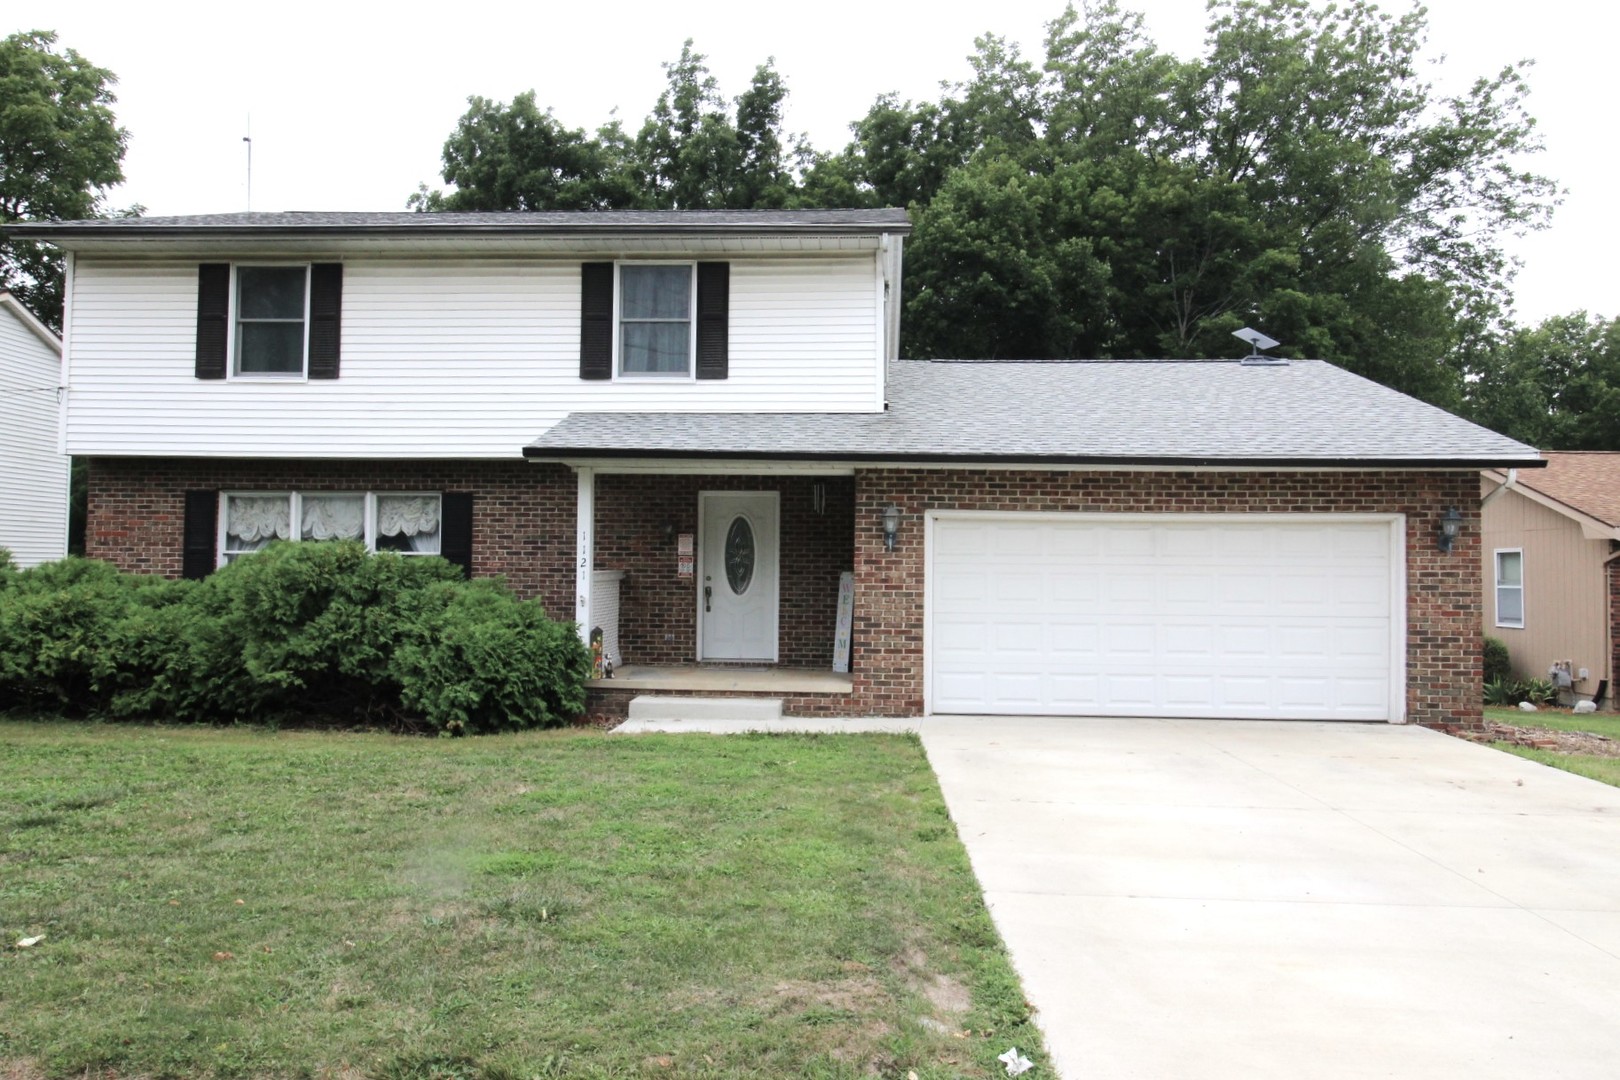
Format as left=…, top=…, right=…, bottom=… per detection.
left=5, top=209, right=910, bottom=238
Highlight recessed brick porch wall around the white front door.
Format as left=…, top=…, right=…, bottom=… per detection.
left=596, top=474, right=855, bottom=669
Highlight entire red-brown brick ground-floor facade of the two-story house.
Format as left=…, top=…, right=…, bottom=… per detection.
left=86, top=458, right=1483, bottom=724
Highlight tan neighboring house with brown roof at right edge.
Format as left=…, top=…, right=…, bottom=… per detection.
left=1481, top=452, right=1620, bottom=699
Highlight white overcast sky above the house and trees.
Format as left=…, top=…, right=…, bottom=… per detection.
left=9, top=0, right=1620, bottom=321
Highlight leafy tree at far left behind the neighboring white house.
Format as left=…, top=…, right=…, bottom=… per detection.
left=0, top=31, right=129, bottom=330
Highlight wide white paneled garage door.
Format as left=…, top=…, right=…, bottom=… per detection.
left=928, top=513, right=1400, bottom=721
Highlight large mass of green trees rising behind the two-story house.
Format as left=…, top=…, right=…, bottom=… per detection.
left=413, top=0, right=1558, bottom=410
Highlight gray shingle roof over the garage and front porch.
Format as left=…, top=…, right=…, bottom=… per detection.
left=525, top=359, right=1541, bottom=468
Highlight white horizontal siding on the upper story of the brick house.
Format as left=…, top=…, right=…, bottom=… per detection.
left=66, top=253, right=883, bottom=458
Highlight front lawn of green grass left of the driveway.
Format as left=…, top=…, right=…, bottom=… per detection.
left=0, top=722, right=1050, bottom=1080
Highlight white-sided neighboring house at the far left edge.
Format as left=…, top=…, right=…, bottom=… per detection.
left=0, top=291, right=68, bottom=567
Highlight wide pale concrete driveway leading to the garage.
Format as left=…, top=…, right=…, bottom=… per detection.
left=919, top=717, right=1620, bottom=1080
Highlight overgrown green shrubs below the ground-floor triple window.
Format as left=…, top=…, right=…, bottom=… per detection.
left=0, top=542, right=588, bottom=733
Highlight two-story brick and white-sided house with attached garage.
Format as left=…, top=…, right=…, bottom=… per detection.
left=11, top=210, right=1541, bottom=724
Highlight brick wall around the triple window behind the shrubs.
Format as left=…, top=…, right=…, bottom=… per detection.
left=84, top=458, right=577, bottom=620
